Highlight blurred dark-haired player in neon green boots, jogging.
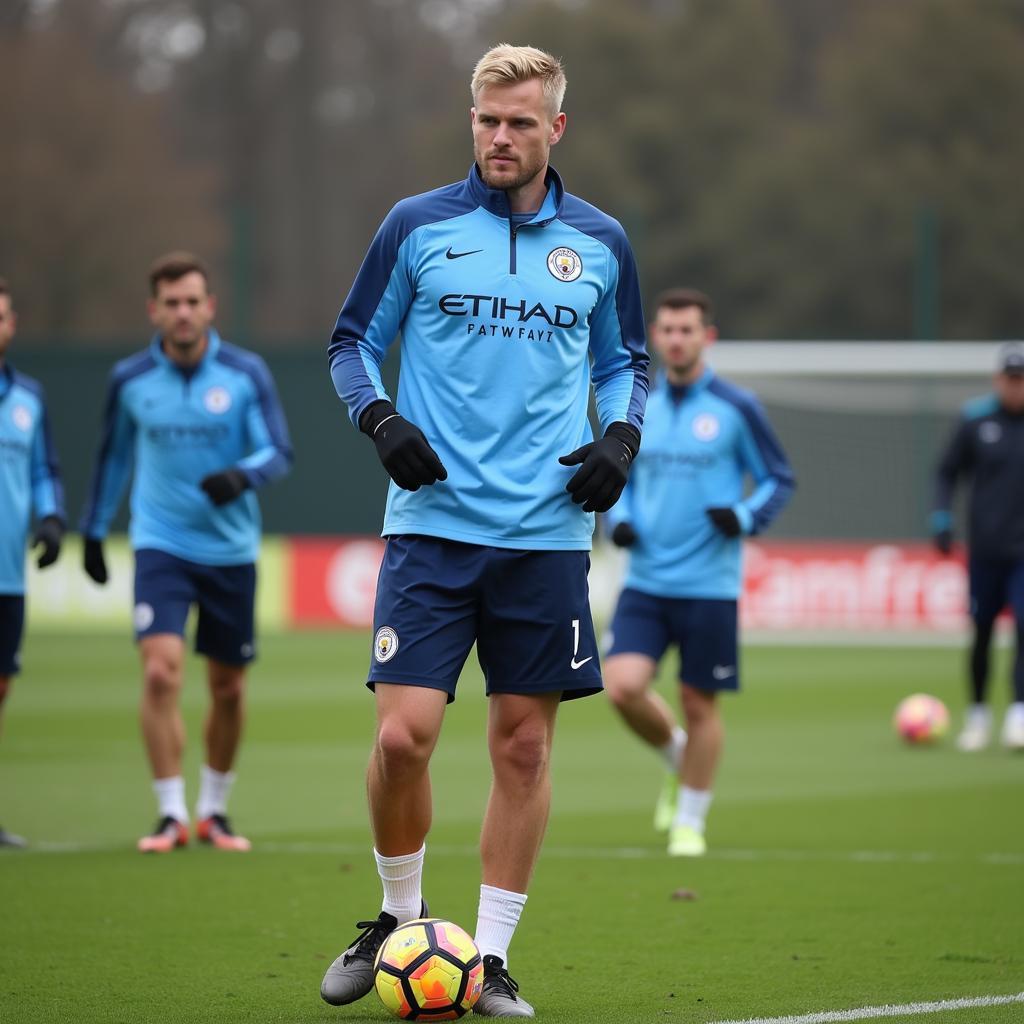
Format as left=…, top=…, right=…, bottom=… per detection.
left=604, top=289, right=794, bottom=856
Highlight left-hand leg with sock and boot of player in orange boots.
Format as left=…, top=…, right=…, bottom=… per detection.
left=138, top=633, right=188, bottom=853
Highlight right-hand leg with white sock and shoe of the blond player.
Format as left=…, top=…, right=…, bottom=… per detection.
left=474, top=693, right=561, bottom=1017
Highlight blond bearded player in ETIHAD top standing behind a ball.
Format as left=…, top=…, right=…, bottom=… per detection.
left=321, top=44, right=648, bottom=1017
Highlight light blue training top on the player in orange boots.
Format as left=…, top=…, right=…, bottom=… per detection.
left=81, top=330, right=292, bottom=565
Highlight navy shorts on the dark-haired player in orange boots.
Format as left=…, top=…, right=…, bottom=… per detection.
left=133, top=548, right=256, bottom=665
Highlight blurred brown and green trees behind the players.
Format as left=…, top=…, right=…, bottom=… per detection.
left=0, top=0, right=1024, bottom=344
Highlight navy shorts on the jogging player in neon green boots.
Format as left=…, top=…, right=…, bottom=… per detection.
left=605, top=588, right=739, bottom=690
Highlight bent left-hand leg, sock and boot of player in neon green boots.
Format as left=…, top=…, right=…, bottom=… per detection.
left=603, top=653, right=686, bottom=831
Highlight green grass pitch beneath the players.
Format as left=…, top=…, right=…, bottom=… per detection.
left=0, top=633, right=1024, bottom=1024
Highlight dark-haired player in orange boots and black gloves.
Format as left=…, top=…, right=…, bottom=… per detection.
left=81, top=252, right=292, bottom=853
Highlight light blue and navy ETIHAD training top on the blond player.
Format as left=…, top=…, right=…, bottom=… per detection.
left=328, top=165, right=648, bottom=550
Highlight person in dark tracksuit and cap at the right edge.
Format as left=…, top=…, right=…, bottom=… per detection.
left=931, top=342, right=1024, bottom=751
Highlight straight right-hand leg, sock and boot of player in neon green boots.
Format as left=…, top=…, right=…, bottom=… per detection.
left=669, top=683, right=725, bottom=856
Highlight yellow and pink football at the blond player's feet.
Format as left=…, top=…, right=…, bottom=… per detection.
left=374, top=918, right=483, bottom=1021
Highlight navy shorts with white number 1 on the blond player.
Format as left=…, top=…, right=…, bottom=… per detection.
left=367, top=534, right=601, bottom=702
